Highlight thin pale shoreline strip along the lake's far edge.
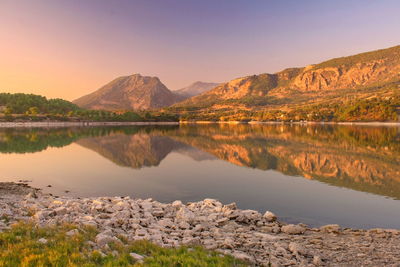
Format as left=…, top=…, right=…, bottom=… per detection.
left=0, top=121, right=400, bottom=128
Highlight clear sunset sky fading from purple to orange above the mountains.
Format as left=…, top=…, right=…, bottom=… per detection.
left=0, top=0, right=400, bottom=100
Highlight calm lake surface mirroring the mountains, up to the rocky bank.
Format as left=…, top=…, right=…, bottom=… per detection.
left=0, top=125, right=400, bottom=228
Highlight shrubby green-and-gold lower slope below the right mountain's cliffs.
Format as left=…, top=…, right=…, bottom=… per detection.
left=170, top=82, right=400, bottom=122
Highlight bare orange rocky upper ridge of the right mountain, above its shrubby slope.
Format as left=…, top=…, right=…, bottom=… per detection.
left=177, top=46, right=400, bottom=108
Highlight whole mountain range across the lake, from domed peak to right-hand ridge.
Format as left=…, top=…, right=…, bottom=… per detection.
left=73, top=46, right=400, bottom=120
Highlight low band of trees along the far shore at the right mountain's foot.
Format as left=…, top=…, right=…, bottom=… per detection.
left=175, top=97, right=400, bottom=122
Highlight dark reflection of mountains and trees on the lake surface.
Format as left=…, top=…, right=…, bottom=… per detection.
left=0, top=124, right=400, bottom=199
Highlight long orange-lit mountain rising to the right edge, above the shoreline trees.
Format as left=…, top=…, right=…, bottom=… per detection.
left=174, top=46, right=400, bottom=121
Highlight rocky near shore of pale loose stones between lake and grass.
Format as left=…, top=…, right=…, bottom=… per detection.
left=0, top=183, right=400, bottom=266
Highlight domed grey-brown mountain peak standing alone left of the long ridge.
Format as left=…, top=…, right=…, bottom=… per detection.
left=73, top=74, right=183, bottom=110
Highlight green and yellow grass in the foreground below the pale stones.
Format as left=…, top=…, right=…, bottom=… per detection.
left=0, top=223, right=246, bottom=267
